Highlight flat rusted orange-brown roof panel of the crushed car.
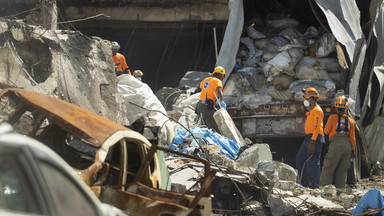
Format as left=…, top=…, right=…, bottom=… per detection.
left=3, top=89, right=131, bottom=147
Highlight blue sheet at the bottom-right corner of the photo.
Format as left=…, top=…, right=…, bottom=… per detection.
left=352, top=188, right=384, bottom=216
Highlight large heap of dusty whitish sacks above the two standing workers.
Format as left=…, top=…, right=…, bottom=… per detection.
left=224, top=14, right=344, bottom=109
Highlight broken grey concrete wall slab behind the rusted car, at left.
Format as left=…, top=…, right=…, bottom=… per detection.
left=0, top=20, right=127, bottom=124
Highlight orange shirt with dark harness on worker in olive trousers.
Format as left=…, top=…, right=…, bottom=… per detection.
left=324, top=114, right=356, bottom=150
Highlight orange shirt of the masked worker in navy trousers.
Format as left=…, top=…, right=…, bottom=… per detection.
left=305, top=104, right=324, bottom=140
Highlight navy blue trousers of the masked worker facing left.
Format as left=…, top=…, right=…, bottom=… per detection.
left=296, top=134, right=325, bottom=188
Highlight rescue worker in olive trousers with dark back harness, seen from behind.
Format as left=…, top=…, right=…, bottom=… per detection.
left=320, top=96, right=355, bottom=190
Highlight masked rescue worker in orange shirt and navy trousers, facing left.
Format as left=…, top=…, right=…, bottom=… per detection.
left=296, top=88, right=325, bottom=188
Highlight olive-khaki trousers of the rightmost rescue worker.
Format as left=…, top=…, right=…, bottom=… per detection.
left=320, top=133, right=351, bottom=189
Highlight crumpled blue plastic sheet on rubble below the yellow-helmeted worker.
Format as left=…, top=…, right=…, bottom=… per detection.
left=168, top=127, right=239, bottom=159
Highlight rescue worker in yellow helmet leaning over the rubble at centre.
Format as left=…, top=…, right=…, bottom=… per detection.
left=196, top=66, right=227, bottom=132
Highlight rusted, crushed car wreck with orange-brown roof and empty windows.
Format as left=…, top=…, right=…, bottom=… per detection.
left=0, top=89, right=215, bottom=215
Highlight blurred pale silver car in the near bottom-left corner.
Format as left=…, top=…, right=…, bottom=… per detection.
left=0, top=123, right=126, bottom=216
